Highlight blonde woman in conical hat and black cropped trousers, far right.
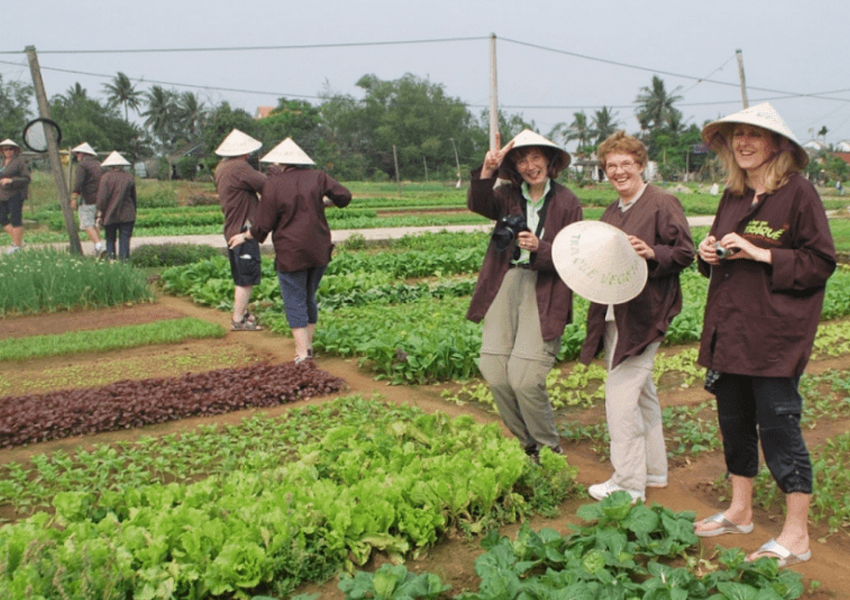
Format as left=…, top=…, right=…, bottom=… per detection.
left=694, top=103, right=836, bottom=566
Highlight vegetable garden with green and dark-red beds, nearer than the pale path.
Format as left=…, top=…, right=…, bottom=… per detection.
left=0, top=180, right=850, bottom=600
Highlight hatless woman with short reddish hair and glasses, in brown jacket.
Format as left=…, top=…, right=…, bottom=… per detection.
left=580, top=131, right=694, bottom=500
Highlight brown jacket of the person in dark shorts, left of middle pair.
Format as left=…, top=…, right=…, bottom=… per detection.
left=214, top=157, right=266, bottom=240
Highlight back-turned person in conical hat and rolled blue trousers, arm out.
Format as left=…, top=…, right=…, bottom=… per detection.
left=228, top=138, right=351, bottom=363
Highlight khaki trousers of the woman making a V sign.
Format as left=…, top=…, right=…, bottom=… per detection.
left=479, top=268, right=561, bottom=451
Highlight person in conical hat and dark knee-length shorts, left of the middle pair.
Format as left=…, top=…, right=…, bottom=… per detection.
left=213, top=129, right=266, bottom=331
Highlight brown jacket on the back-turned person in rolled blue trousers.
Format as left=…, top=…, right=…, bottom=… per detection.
left=251, top=168, right=351, bottom=273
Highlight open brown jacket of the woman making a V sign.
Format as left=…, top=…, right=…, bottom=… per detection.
left=466, top=168, right=582, bottom=341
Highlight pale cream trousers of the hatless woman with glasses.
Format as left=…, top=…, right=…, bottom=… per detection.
left=604, top=321, right=667, bottom=492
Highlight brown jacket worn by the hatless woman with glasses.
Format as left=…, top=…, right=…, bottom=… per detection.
left=580, top=185, right=695, bottom=366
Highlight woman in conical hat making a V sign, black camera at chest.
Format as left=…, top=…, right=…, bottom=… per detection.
left=466, top=129, right=582, bottom=459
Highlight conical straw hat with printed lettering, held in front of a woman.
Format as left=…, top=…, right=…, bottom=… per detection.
left=552, top=221, right=647, bottom=304
